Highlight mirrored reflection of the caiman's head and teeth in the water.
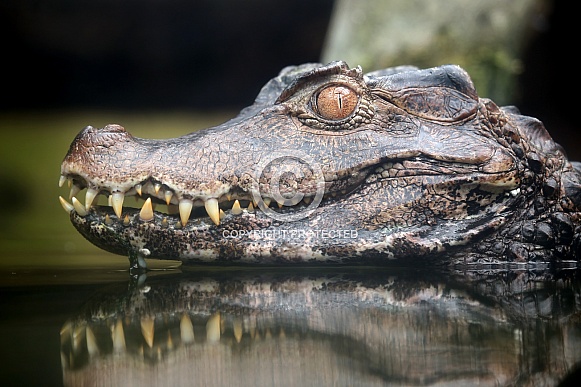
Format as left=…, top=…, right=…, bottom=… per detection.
left=61, top=269, right=581, bottom=386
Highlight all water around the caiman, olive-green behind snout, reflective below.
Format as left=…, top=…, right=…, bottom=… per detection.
left=0, top=112, right=581, bottom=386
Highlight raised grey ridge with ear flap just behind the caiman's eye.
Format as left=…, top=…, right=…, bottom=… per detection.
left=368, top=65, right=478, bottom=122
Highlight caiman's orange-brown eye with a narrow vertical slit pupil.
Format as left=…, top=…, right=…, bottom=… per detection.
left=315, top=85, right=359, bottom=121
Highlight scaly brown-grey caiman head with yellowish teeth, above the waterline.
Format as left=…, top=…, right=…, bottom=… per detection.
left=59, top=62, right=581, bottom=266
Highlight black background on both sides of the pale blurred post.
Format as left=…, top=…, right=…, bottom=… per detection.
left=0, top=0, right=581, bottom=158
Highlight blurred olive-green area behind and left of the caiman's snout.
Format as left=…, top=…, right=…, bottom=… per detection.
left=0, top=111, right=231, bottom=284
